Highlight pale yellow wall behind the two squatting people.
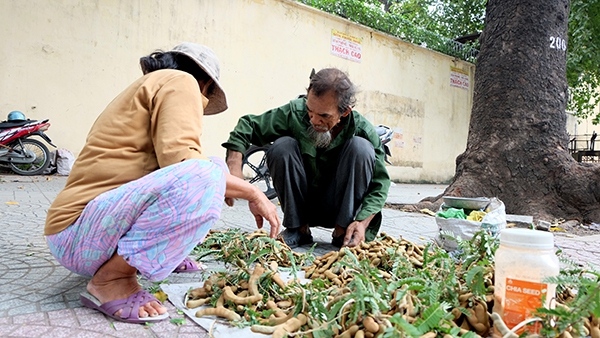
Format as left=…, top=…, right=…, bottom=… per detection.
left=0, top=0, right=475, bottom=182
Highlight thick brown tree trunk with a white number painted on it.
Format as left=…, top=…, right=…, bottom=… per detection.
left=415, top=0, right=600, bottom=223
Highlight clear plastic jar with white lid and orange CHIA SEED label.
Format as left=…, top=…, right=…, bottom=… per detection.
left=493, top=228, right=560, bottom=337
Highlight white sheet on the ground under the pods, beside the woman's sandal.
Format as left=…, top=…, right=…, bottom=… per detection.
left=160, top=271, right=306, bottom=338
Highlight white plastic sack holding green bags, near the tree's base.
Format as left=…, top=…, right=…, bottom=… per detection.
left=435, top=197, right=506, bottom=251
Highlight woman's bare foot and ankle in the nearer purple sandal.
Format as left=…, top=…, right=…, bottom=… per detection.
left=87, top=254, right=167, bottom=318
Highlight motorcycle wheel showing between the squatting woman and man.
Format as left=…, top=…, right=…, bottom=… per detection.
left=242, top=145, right=277, bottom=199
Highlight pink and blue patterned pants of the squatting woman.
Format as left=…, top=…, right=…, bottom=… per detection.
left=46, top=157, right=227, bottom=281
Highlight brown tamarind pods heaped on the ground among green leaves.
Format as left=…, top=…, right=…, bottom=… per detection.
left=186, top=231, right=600, bottom=338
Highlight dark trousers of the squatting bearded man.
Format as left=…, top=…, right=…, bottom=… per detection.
left=267, top=136, right=375, bottom=229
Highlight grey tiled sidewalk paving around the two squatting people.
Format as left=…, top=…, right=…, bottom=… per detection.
left=0, top=175, right=600, bottom=338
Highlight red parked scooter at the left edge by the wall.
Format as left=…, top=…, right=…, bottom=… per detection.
left=0, top=111, right=56, bottom=176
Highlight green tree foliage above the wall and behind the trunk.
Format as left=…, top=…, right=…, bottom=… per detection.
left=297, top=0, right=600, bottom=124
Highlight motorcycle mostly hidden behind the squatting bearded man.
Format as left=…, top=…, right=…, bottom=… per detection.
left=242, top=124, right=394, bottom=199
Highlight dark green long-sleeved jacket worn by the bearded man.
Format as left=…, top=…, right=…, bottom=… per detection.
left=222, top=98, right=390, bottom=221
